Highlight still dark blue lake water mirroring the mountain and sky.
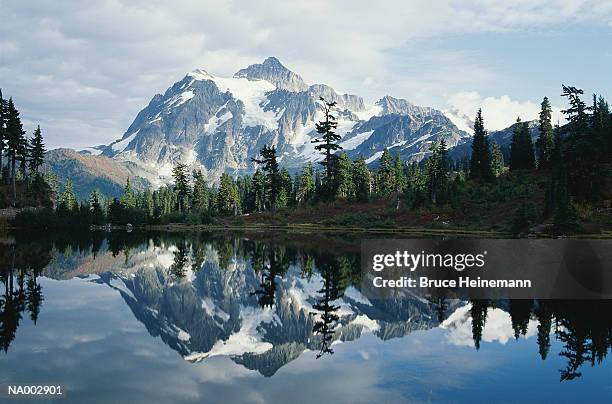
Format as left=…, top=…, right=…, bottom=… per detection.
left=0, top=233, right=612, bottom=403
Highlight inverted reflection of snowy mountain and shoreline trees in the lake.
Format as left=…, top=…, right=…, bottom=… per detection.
left=0, top=233, right=612, bottom=400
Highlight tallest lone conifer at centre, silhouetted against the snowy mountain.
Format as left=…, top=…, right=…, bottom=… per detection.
left=312, top=97, right=342, bottom=198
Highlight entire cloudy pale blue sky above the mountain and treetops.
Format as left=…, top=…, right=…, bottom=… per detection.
left=0, top=0, right=612, bottom=147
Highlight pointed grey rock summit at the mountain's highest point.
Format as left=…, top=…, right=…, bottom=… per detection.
left=234, top=56, right=308, bottom=92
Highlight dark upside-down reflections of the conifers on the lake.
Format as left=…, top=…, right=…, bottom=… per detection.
left=0, top=232, right=612, bottom=382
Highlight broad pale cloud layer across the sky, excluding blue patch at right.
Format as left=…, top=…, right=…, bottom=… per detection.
left=0, top=0, right=612, bottom=145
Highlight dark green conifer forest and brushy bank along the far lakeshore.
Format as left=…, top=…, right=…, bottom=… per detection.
left=0, top=86, right=612, bottom=237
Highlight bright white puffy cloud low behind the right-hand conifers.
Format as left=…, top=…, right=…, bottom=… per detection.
left=447, top=91, right=563, bottom=130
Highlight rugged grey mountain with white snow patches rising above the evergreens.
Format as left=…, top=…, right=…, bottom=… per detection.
left=95, top=57, right=469, bottom=185
